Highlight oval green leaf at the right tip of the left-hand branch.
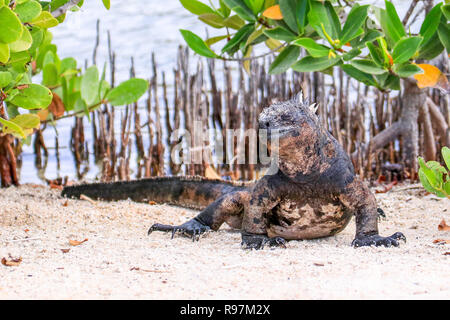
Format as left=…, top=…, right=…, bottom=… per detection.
left=105, top=78, right=148, bottom=106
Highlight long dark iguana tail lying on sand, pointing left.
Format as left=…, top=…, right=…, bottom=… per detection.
left=62, top=176, right=249, bottom=210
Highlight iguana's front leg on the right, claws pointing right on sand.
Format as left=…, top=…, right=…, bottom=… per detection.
left=340, top=178, right=406, bottom=247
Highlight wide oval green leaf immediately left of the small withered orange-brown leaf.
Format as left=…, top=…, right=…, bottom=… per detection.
left=11, top=84, right=53, bottom=109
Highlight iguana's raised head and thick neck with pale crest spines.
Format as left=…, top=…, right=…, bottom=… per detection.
left=259, top=93, right=354, bottom=187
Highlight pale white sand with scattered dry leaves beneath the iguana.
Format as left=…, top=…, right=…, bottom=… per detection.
left=0, top=185, right=450, bottom=299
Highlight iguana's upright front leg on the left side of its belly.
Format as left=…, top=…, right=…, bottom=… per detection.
left=241, top=176, right=286, bottom=249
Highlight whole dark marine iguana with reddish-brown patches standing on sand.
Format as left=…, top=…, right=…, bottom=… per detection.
left=62, top=95, right=406, bottom=249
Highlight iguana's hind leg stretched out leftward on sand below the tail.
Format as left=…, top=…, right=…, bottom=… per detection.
left=148, top=190, right=248, bottom=241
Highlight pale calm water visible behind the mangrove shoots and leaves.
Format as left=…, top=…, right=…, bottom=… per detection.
left=20, top=0, right=416, bottom=183
